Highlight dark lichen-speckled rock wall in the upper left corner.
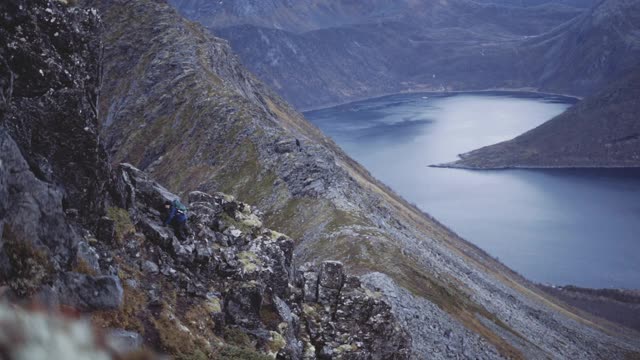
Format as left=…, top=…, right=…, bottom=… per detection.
left=0, top=0, right=111, bottom=223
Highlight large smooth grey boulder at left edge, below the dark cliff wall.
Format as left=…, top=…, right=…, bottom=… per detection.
left=0, top=129, right=81, bottom=296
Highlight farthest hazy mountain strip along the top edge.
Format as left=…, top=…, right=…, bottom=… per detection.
left=169, top=0, right=586, bottom=33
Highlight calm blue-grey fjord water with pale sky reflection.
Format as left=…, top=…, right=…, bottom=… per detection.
left=306, top=93, right=640, bottom=288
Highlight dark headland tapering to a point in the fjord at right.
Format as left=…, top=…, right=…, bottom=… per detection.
left=440, top=66, right=640, bottom=168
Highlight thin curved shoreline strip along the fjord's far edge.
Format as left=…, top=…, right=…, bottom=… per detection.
left=296, top=88, right=584, bottom=115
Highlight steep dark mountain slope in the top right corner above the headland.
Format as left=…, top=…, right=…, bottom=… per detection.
left=523, top=0, right=640, bottom=95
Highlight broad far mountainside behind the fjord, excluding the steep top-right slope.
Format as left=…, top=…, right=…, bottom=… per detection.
left=173, top=0, right=582, bottom=109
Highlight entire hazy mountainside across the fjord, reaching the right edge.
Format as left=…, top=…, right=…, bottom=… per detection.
left=172, top=0, right=640, bottom=109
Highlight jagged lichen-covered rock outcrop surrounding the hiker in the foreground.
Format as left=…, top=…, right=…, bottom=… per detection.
left=96, top=164, right=410, bottom=359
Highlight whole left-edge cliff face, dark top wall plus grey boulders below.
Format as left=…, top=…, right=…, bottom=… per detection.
left=0, top=0, right=122, bottom=311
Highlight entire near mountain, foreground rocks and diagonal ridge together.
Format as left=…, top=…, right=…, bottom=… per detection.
left=0, top=0, right=640, bottom=360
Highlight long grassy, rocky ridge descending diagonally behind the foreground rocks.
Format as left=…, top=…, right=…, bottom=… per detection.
left=93, top=0, right=639, bottom=359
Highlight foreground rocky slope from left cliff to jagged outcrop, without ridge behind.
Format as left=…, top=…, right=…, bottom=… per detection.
left=0, top=0, right=410, bottom=359
